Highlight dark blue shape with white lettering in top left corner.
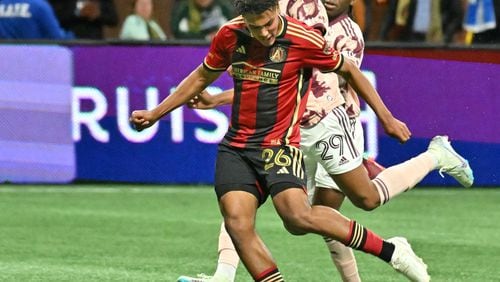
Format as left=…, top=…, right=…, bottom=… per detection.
left=0, top=0, right=71, bottom=39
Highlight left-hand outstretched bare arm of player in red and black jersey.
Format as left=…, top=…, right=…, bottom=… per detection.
left=129, top=65, right=221, bottom=131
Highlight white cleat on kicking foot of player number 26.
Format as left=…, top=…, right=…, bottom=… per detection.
left=387, top=237, right=431, bottom=282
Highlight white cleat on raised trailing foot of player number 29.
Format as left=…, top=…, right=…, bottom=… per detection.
left=428, top=136, right=474, bottom=187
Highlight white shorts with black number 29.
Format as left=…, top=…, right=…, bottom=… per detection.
left=300, top=106, right=364, bottom=200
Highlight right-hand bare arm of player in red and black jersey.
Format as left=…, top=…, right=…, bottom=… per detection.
left=337, top=60, right=411, bottom=143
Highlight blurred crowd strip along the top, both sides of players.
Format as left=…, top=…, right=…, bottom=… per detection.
left=0, top=0, right=500, bottom=44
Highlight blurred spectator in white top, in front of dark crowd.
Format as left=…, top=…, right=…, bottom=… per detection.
left=120, top=0, right=167, bottom=40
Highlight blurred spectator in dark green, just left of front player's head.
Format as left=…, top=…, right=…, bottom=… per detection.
left=171, top=0, right=235, bottom=40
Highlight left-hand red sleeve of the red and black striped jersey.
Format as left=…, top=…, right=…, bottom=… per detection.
left=203, top=25, right=236, bottom=71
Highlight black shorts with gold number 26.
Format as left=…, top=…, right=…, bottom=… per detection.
left=215, top=144, right=306, bottom=204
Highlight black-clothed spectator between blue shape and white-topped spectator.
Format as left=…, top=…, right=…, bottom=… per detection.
left=49, top=0, right=118, bottom=39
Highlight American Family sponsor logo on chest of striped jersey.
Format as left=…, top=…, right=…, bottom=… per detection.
left=233, top=62, right=281, bottom=85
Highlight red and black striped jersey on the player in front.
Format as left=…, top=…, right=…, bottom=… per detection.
left=204, top=16, right=343, bottom=148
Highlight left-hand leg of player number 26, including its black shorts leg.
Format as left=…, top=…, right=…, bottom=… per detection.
left=215, top=145, right=282, bottom=281
